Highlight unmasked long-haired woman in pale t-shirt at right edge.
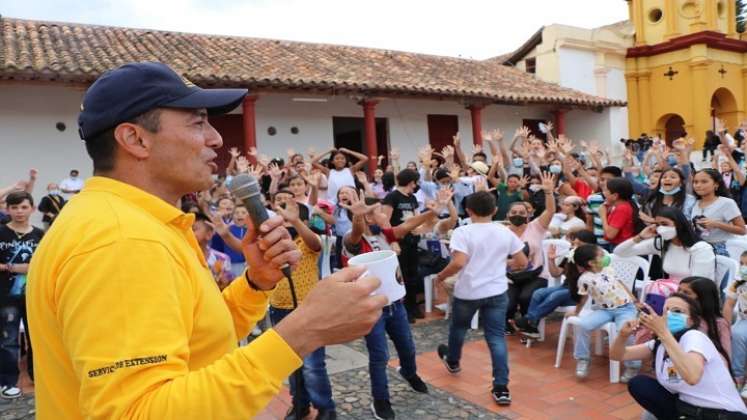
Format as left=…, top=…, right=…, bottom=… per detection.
left=690, top=169, right=747, bottom=256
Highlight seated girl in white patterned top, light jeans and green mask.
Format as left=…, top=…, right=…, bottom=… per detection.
left=565, top=245, right=641, bottom=383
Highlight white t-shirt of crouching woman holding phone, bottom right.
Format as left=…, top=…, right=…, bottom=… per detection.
left=646, top=330, right=747, bottom=414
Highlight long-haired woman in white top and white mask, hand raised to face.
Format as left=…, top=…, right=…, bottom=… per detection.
left=614, top=207, right=716, bottom=297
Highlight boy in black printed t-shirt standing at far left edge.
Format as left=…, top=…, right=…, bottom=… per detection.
left=0, top=191, right=44, bottom=398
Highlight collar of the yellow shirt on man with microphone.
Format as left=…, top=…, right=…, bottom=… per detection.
left=81, top=176, right=194, bottom=228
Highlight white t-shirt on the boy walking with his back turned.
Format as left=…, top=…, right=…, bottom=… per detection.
left=450, top=223, right=524, bottom=300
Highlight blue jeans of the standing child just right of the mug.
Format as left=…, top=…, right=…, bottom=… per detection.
left=366, top=301, right=417, bottom=400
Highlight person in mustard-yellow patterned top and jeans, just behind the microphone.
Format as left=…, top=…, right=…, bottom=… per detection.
left=270, top=193, right=337, bottom=420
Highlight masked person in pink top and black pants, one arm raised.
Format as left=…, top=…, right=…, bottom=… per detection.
left=506, top=173, right=555, bottom=334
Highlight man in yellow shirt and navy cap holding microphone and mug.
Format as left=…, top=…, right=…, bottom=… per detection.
left=27, top=63, right=386, bottom=420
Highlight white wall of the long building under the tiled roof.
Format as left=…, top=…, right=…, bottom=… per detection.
left=0, top=85, right=624, bottom=208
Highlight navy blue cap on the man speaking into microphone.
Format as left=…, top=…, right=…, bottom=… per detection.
left=78, top=62, right=247, bottom=140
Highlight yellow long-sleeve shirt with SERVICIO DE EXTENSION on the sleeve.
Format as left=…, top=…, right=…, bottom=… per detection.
left=27, top=177, right=301, bottom=420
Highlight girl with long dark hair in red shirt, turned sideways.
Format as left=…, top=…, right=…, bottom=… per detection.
left=599, top=178, right=643, bottom=247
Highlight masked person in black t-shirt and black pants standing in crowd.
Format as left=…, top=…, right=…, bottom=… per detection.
left=382, top=169, right=424, bottom=323
